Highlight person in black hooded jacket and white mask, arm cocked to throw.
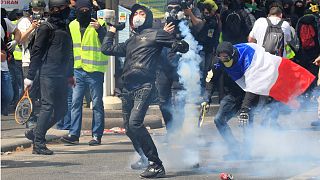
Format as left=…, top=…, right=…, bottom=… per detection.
left=101, top=4, right=189, bottom=178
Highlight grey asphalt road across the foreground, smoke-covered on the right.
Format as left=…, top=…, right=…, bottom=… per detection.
left=1, top=106, right=320, bottom=180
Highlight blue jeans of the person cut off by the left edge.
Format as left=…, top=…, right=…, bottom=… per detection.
left=1, top=71, right=13, bottom=112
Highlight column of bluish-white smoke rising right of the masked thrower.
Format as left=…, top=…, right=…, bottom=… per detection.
left=159, top=21, right=206, bottom=169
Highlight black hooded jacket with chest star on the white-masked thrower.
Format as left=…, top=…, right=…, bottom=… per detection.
left=101, top=4, right=179, bottom=89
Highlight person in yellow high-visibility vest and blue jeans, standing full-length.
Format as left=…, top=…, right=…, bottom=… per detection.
left=62, top=0, right=108, bottom=146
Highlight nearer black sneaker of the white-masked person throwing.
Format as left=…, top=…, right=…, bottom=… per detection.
left=140, top=162, right=166, bottom=178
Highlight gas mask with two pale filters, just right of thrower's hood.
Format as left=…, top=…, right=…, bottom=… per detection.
left=164, top=6, right=185, bottom=26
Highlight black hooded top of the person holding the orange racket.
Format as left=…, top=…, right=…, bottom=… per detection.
left=27, top=17, right=73, bottom=80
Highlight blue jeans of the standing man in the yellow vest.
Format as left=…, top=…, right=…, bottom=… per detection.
left=69, top=69, right=104, bottom=138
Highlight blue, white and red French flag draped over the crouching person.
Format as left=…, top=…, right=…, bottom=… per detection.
left=225, top=43, right=315, bottom=104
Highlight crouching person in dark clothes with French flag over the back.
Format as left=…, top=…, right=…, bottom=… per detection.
left=205, top=42, right=315, bottom=157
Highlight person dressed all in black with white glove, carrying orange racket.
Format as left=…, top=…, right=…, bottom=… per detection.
left=24, top=0, right=74, bottom=155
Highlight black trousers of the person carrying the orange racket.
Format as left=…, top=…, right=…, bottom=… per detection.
left=34, top=77, right=68, bottom=147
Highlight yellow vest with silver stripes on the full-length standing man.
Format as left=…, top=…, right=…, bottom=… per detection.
left=69, top=19, right=109, bottom=72
